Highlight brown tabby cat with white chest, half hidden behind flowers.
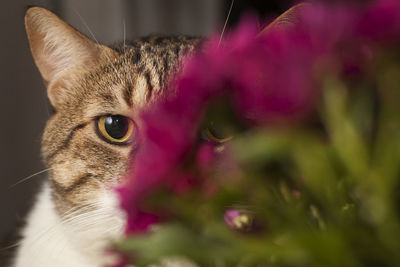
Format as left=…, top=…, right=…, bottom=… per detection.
left=11, top=4, right=304, bottom=267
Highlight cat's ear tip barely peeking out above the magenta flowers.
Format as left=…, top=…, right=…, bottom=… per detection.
left=257, top=3, right=310, bottom=37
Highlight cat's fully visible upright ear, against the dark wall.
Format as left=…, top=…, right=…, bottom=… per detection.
left=25, top=7, right=113, bottom=96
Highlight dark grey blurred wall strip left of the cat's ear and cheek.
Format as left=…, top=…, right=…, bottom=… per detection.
left=0, top=0, right=51, bottom=251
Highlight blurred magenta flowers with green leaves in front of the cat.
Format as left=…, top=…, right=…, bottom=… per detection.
left=117, top=0, right=400, bottom=266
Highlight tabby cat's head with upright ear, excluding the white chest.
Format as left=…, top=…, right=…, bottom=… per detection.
left=25, top=7, right=198, bottom=241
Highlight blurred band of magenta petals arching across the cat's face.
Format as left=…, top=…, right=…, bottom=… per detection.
left=119, top=0, right=400, bottom=233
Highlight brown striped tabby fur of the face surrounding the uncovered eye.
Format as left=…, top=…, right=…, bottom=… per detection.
left=42, top=36, right=197, bottom=216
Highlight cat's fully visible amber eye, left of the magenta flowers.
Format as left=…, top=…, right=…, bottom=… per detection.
left=97, top=115, right=135, bottom=144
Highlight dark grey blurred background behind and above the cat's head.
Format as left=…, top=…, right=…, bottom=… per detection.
left=0, top=0, right=293, bottom=252
